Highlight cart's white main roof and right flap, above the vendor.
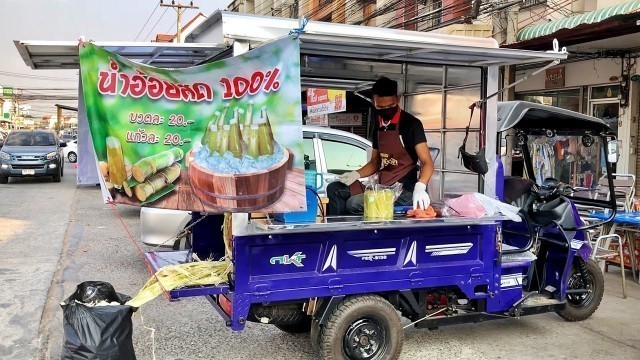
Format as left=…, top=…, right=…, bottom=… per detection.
left=187, top=11, right=567, bottom=66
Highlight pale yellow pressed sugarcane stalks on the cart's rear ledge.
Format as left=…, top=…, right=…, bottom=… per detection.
left=126, top=260, right=232, bottom=307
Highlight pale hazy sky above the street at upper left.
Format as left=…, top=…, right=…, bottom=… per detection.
left=0, top=0, right=232, bottom=117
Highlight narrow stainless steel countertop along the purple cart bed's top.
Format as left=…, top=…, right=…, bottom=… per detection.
left=234, top=215, right=509, bottom=236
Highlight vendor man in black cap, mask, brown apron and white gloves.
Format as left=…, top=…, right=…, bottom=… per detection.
left=327, top=76, right=433, bottom=216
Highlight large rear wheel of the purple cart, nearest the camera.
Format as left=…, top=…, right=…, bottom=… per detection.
left=318, top=295, right=404, bottom=360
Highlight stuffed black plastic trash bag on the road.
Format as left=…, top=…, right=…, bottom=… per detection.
left=60, top=281, right=137, bottom=360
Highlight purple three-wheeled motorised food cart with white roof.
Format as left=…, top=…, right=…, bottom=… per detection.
left=13, top=12, right=615, bottom=359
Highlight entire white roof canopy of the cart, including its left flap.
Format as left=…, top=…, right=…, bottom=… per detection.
left=14, top=11, right=567, bottom=69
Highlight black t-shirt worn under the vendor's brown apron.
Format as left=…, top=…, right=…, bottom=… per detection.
left=372, top=110, right=427, bottom=191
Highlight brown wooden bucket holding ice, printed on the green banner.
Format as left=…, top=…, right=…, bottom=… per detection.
left=188, top=149, right=291, bottom=211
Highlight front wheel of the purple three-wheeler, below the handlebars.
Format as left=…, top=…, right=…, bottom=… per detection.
left=556, top=259, right=604, bottom=321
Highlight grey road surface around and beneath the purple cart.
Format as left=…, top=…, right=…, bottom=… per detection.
left=0, top=166, right=640, bottom=360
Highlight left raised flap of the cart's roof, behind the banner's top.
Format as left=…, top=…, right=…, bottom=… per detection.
left=14, top=40, right=229, bottom=70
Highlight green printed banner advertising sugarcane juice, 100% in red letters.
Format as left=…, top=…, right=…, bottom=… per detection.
left=80, top=37, right=306, bottom=213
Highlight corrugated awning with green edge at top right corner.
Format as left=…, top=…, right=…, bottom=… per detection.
left=518, top=0, right=640, bottom=41
